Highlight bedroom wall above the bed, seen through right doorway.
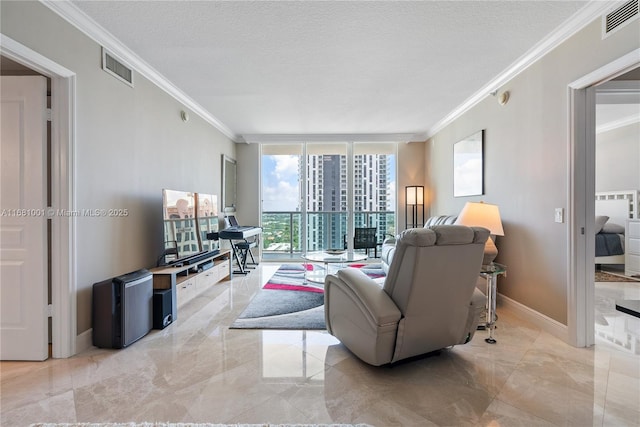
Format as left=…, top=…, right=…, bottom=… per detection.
left=596, top=123, right=640, bottom=191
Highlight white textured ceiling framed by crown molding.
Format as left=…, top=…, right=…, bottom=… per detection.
left=67, top=1, right=587, bottom=140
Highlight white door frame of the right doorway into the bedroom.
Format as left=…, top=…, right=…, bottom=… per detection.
left=567, top=49, right=640, bottom=347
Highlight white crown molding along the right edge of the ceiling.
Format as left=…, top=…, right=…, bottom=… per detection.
left=425, top=0, right=623, bottom=138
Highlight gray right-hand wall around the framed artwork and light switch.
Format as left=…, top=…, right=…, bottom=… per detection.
left=426, top=19, right=640, bottom=325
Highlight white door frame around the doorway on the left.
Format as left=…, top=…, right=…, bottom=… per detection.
left=0, top=34, right=77, bottom=358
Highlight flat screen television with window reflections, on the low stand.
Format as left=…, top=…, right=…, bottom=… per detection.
left=160, top=189, right=218, bottom=264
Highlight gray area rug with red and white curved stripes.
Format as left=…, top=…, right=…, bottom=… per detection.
left=229, top=264, right=384, bottom=330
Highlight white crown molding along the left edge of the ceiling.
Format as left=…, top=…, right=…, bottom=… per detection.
left=40, top=0, right=239, bottom=142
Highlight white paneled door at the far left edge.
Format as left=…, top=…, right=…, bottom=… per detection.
left=0, top=76, right=48, bottom=360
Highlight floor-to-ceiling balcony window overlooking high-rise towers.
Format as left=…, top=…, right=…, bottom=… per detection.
left=261, top=143, right=396, bottom=259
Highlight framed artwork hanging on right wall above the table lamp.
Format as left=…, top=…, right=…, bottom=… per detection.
left=453, top=130, right=484, bottom=197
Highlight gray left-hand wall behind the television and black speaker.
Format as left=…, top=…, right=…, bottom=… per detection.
left=1, top=2, right=235, bottom=333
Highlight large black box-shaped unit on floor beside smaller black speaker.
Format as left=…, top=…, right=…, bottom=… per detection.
left=92, top=269, right=153, bottom=348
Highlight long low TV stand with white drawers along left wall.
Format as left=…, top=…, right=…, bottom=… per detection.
left=150, top=249, right=232, bottom=321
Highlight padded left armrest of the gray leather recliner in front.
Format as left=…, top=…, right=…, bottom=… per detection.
left=327, top=268, right=402, bottom=326
